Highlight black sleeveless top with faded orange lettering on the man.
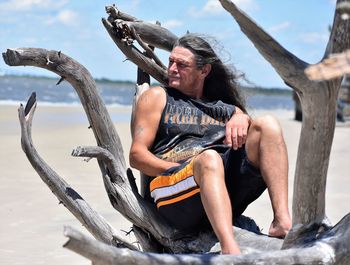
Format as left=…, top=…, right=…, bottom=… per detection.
left=151, top=88, right=235, bottom=162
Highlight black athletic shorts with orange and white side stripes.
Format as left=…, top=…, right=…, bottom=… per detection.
left=150, top=147, right=266, bottom=230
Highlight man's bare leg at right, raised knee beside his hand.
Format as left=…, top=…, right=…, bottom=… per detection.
left=246, top=116, right=292, bottom=237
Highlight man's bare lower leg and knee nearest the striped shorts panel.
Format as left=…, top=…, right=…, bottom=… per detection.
left=193, top=150, right=240, bottom=254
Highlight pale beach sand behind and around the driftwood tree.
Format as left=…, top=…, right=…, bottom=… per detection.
left=0, top=102, right=350, bottom=265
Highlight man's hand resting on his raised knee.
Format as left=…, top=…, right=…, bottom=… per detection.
left=224, top=107, right=251, bottom=150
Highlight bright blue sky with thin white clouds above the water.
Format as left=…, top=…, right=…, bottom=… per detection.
left=0, top=0, right=336, bottom=87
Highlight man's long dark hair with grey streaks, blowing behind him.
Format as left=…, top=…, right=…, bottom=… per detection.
left=174, top=33, right=246, bottom=112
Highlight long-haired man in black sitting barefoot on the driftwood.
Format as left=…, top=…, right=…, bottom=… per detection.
left=130, top=34, right=291, bottom=254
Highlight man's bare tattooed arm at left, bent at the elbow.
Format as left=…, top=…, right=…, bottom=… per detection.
left=129, top=87, right=178, bottom=176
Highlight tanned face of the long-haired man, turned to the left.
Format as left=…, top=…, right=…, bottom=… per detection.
left=168, top=46, right=205, bottom=96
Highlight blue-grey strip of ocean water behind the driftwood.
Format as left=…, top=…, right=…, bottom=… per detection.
left=0, top=76, right=294, bottom=110
